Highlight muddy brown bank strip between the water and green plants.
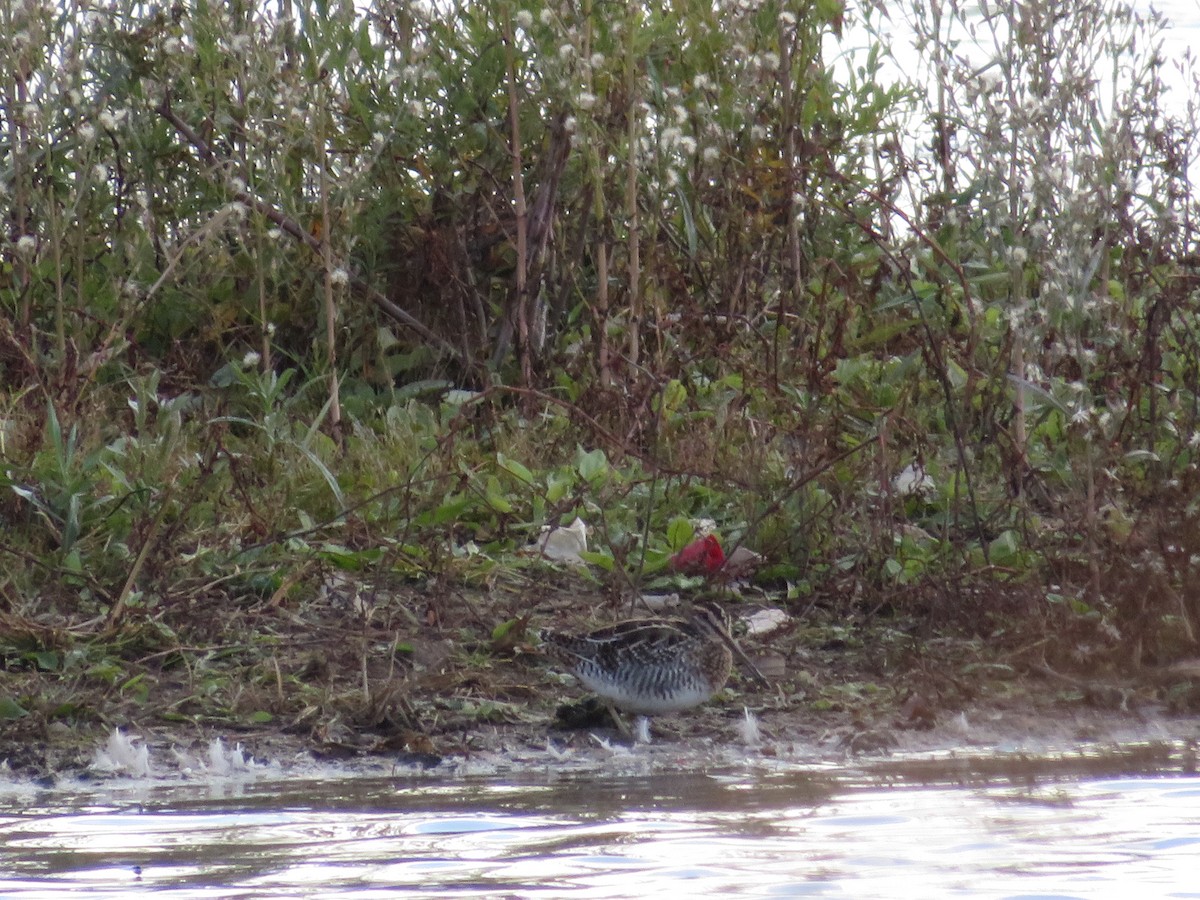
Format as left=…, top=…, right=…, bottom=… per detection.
left=0, top=575, right=1200, bottom=781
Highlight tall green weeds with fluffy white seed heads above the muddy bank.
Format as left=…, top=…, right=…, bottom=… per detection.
left=0, top=0, right=1200, bottom=676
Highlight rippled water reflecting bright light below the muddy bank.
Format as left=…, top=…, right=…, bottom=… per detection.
left=0, top=745, right=1200, bottom=898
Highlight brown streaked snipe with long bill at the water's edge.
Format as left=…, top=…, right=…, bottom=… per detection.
left=541, top=604, right=767, bottom=734
